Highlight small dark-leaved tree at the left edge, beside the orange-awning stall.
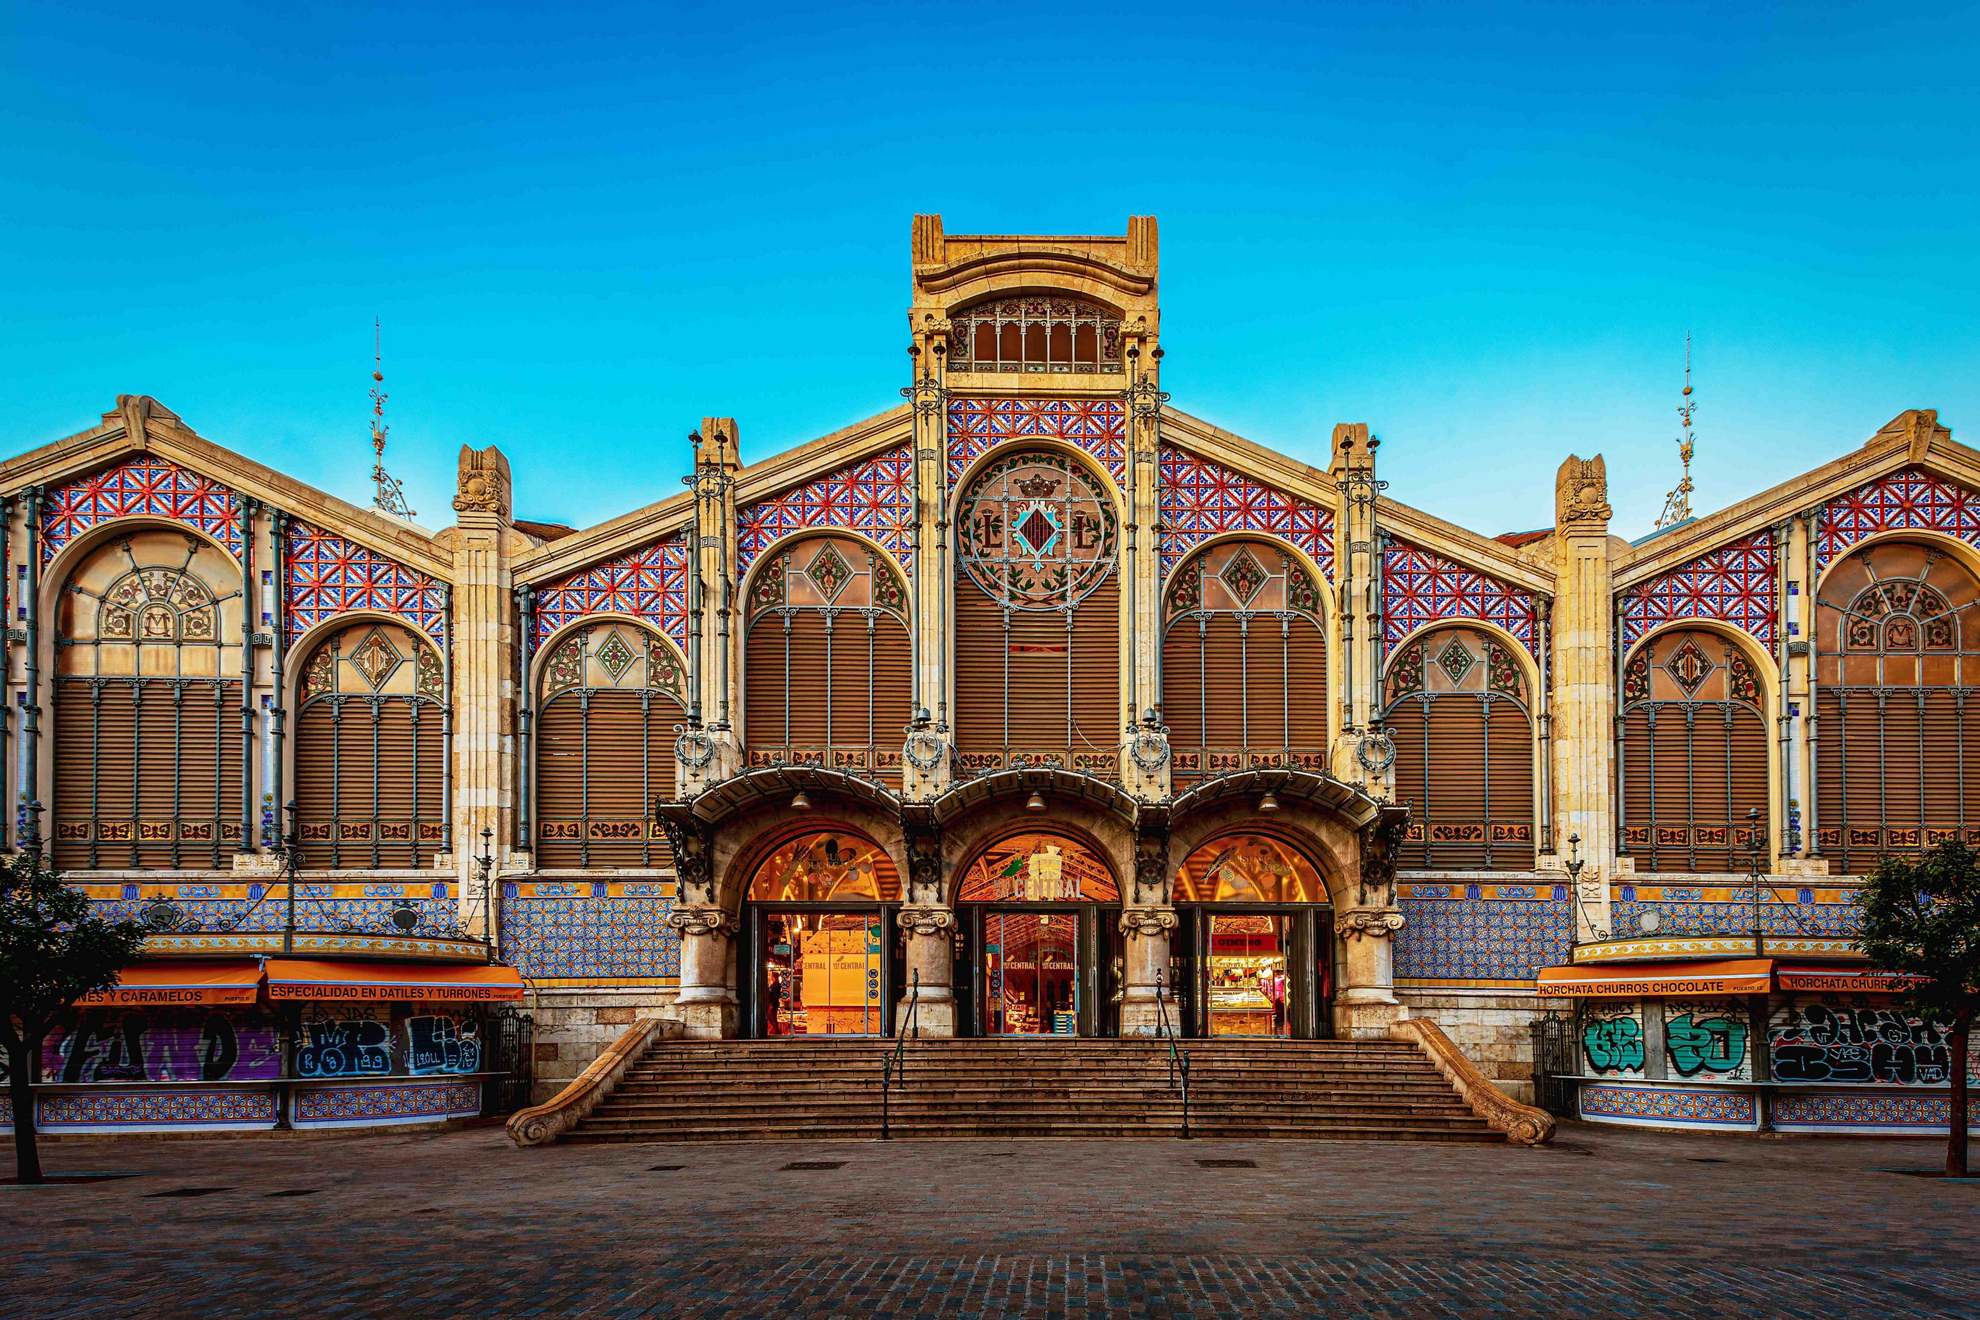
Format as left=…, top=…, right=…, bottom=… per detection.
left=0, top=845, right=145, bottom=1183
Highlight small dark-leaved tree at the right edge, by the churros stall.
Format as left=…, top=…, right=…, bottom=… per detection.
left=1857, top=839, right=1980, bottom=1178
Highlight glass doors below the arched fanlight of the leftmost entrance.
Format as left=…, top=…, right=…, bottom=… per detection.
left=756, top=910, right=889, bottom=1037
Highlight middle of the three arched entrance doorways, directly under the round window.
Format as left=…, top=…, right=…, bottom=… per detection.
left=954, top=829, right=1121, bottom=1037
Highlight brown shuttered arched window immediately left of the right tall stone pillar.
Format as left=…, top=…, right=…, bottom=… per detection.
left=1382, top=627, right=1535, bottom=871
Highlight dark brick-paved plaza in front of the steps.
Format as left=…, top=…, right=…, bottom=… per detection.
left=0, top=1124, right=1980, bottom=1318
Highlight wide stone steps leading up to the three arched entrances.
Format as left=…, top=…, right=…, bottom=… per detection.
left=562, top=1037, right=1503, bottom=1142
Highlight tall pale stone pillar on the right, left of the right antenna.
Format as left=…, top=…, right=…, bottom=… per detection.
left=1552, top=453, right=1616, bottom=940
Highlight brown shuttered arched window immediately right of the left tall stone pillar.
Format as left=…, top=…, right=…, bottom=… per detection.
left=537, top=621, right=687, bottom=869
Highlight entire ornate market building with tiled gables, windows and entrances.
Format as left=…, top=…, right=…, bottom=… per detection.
left=0, top=216, right=1980, bottom=1130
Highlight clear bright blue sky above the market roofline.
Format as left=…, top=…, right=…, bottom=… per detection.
left=0, top=2, right=1980, bottom=536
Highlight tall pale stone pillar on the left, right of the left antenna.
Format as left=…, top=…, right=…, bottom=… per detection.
left=440, top=445, right=533, bottom=934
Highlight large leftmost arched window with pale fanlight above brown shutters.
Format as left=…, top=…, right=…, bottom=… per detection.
left=53, top=530, right=242, bottom=871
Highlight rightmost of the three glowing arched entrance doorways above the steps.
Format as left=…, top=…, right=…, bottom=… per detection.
left=1170, top=829, right=1335, bottom=1041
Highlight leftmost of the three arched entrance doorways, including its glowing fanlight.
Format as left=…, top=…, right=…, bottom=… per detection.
left=739, top=827, right=901, bottom=1039
